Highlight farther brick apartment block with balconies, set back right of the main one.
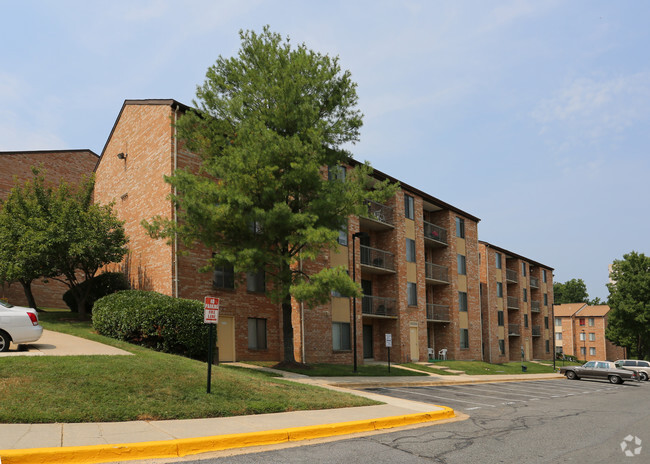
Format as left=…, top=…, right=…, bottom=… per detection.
left=479, top=241, right=553, bottom=363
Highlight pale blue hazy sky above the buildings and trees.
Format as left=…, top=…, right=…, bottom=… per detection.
left=0, top=0, right=650, bottom=298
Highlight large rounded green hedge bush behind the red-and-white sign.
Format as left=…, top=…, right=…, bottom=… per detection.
left=92, top=290, right=208, bottom=359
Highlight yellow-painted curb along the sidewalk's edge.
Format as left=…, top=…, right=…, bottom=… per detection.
left=0, top=406, right=456, bottom=464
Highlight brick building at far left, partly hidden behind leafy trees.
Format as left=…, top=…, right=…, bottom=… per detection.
left=0, top=150, right=99, bottom=308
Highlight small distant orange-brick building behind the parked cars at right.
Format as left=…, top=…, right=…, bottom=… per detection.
left=554, top=303, right=625, bottom=361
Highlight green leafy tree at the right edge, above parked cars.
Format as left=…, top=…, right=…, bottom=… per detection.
left=606, top=251, right=650, bottom=359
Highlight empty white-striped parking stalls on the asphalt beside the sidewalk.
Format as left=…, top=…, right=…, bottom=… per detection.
left=365, top=379, right=650, bottom=411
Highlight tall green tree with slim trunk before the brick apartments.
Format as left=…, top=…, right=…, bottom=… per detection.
left=143, top=27, right=395, bottom=363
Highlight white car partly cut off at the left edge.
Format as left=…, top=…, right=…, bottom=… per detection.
left=0, top=301, right=43, bottom=352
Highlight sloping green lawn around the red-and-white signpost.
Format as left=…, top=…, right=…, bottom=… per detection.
left=0, top=312, right=377, bottom=423
